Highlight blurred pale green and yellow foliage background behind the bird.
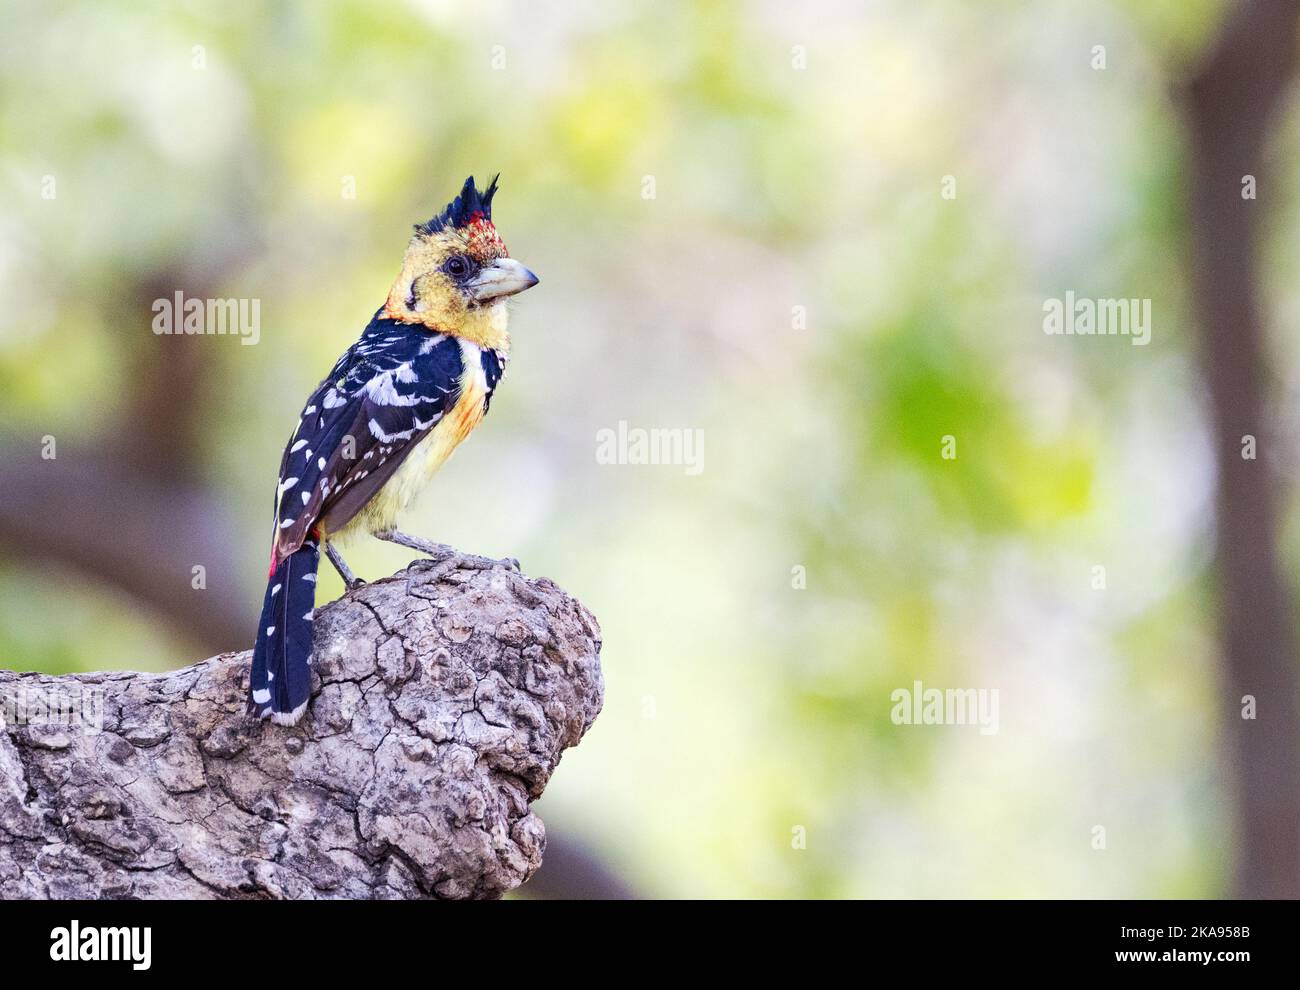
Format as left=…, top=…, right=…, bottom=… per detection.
left=0, top=0, right=1300, bottom=896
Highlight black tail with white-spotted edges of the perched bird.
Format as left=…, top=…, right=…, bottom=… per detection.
left=248, top=537, right=320, bottom=725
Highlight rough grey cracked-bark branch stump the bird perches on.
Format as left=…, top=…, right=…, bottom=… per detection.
left=0, top=555, right=603, bottom=898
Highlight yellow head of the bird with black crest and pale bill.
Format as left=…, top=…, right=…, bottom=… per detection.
left=384, top=175, right=537, bottom=347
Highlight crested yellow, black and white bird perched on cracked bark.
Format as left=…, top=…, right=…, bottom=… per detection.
left=247, top=174, right=538, bottom=725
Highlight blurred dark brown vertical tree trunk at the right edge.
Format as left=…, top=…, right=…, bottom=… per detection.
left=1184, top=0, right=1300, bottom=898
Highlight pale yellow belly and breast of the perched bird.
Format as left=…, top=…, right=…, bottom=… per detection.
left=329, top=342, right=488, bottom=540
